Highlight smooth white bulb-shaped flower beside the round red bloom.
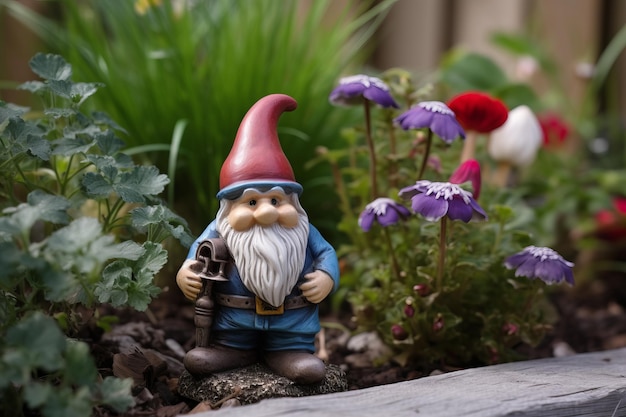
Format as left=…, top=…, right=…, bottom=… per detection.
left=487, top=105, right=543, bottom=167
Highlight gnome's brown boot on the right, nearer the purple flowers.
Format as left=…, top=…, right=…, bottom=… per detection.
left=265, top=350, right=326, bottom=384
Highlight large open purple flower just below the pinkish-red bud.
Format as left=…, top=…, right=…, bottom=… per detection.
left=399, top=180, right=487, bottom=223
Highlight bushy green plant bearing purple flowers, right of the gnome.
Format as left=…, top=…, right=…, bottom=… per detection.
left=320, top=69, right=569, bottom=367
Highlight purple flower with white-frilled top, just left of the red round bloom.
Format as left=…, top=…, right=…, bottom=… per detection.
left=395, top=101, right=465, bottom=143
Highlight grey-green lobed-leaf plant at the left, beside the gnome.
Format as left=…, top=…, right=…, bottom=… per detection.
left=0, top=54, right=192, bottom=416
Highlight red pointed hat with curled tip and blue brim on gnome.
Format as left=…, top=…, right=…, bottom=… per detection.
left=217, top=94, right=302, bottom=200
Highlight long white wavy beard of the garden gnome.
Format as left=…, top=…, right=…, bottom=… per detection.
left=217, top=200, right=309, bottom=307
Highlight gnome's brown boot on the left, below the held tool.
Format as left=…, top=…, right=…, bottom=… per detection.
left=183, top=345, right=258, bottom=376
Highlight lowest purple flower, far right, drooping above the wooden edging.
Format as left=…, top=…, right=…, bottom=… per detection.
left=504, top=246, right=574, bottom=285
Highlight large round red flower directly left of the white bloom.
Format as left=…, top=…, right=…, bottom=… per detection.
left=447, top=91, right=509, bottom=133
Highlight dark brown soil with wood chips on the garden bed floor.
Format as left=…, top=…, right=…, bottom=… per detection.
left=89, top=274, right=626, bottom=417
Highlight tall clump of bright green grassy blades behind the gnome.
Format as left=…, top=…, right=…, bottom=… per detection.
left=1, top=0, right=395, bottom=236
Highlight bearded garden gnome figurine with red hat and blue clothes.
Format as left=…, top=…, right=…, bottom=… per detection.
left=176, top=94, right=339, bottom=384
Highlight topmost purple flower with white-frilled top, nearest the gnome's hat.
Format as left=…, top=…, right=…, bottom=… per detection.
left=328, top=75, right=398, bottom=108
